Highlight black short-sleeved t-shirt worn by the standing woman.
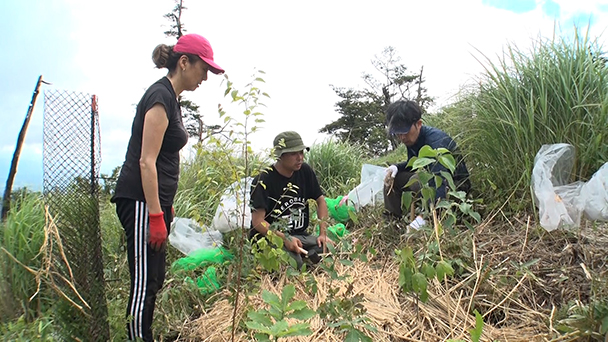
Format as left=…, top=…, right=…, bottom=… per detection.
left=112, top=77, right=188, bottom=207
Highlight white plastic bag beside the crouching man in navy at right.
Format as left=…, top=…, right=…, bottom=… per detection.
left=348, top=164, right=386, bottom=210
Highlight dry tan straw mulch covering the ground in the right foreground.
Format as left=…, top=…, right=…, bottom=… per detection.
left=182, top=219, right=608, bottom=341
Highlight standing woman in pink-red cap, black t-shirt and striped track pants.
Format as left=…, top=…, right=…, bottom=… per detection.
left=112, top=34, right=224, bottom=342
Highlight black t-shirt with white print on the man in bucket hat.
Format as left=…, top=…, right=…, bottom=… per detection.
left=251, top=163, right=323, bottom=235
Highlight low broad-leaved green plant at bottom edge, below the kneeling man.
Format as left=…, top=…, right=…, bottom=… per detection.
left=245, top=284, right=316, bottom=341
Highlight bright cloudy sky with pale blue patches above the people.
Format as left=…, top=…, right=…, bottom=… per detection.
left=0, top=0, right=608, bottom=192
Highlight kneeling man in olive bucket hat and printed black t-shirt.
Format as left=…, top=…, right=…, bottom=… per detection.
left=250, top=131, right=331, bottom=268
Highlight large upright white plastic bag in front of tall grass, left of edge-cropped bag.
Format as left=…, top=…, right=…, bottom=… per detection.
left=532, top=144, right=585, bottom=231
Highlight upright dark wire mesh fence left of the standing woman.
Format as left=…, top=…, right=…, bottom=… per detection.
left=43, top=90, right=110, bottom=342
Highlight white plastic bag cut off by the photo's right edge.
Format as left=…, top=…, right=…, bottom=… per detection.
left=581, top=162, right=608, bottom=221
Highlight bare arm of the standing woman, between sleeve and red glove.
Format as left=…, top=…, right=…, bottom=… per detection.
left=139, top=103, right=169, bottom=214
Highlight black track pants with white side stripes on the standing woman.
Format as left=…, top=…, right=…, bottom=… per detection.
left=116, top=198, right=173, bottom=342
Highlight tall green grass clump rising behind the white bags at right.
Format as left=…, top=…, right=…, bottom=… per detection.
left=440, top=27, right=608, bottom=210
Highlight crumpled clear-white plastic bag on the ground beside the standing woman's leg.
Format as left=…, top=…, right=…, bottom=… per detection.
left=169, top=217, right=223, bottom=255
